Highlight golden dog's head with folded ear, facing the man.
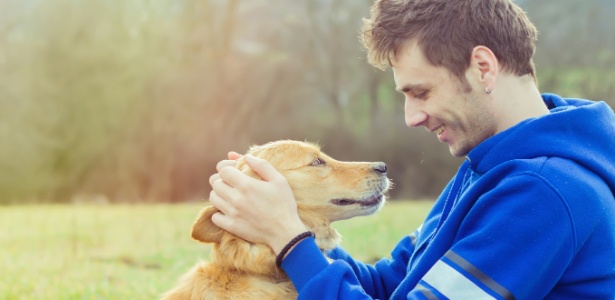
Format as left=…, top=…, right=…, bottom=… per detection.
left=192, top=141, right=390, bottom=268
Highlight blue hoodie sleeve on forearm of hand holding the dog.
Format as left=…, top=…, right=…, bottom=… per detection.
left=282, top=230, right=414, bottom=300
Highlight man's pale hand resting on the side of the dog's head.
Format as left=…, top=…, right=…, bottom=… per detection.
left=209, top=152, right=306, bottom=254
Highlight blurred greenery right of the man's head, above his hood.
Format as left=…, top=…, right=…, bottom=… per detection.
left=521, top=0, right=615, bottom=106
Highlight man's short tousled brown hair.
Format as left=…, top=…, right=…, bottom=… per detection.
left=361, top=0, right=537, bottom=83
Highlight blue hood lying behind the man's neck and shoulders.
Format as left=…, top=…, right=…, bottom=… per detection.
left=468, top=94, right=615, bottom=191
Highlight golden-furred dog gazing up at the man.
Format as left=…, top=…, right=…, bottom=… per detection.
left=163, top=141, right=390, bottom=300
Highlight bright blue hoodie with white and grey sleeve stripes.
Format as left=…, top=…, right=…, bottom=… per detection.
left=282, top=94, right=615, bottom=300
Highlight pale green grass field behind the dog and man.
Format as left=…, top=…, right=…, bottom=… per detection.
left=0, top=201, right=432, bottom=300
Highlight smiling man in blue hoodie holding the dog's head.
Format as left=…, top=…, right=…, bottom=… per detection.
left=210, top=0, right=615, bottom=299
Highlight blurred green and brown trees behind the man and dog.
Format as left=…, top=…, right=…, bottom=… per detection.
left=0, top=0, right=615, bottom=203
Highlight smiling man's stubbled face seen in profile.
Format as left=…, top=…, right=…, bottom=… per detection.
left=392, top=43, right=497, bottom=156
